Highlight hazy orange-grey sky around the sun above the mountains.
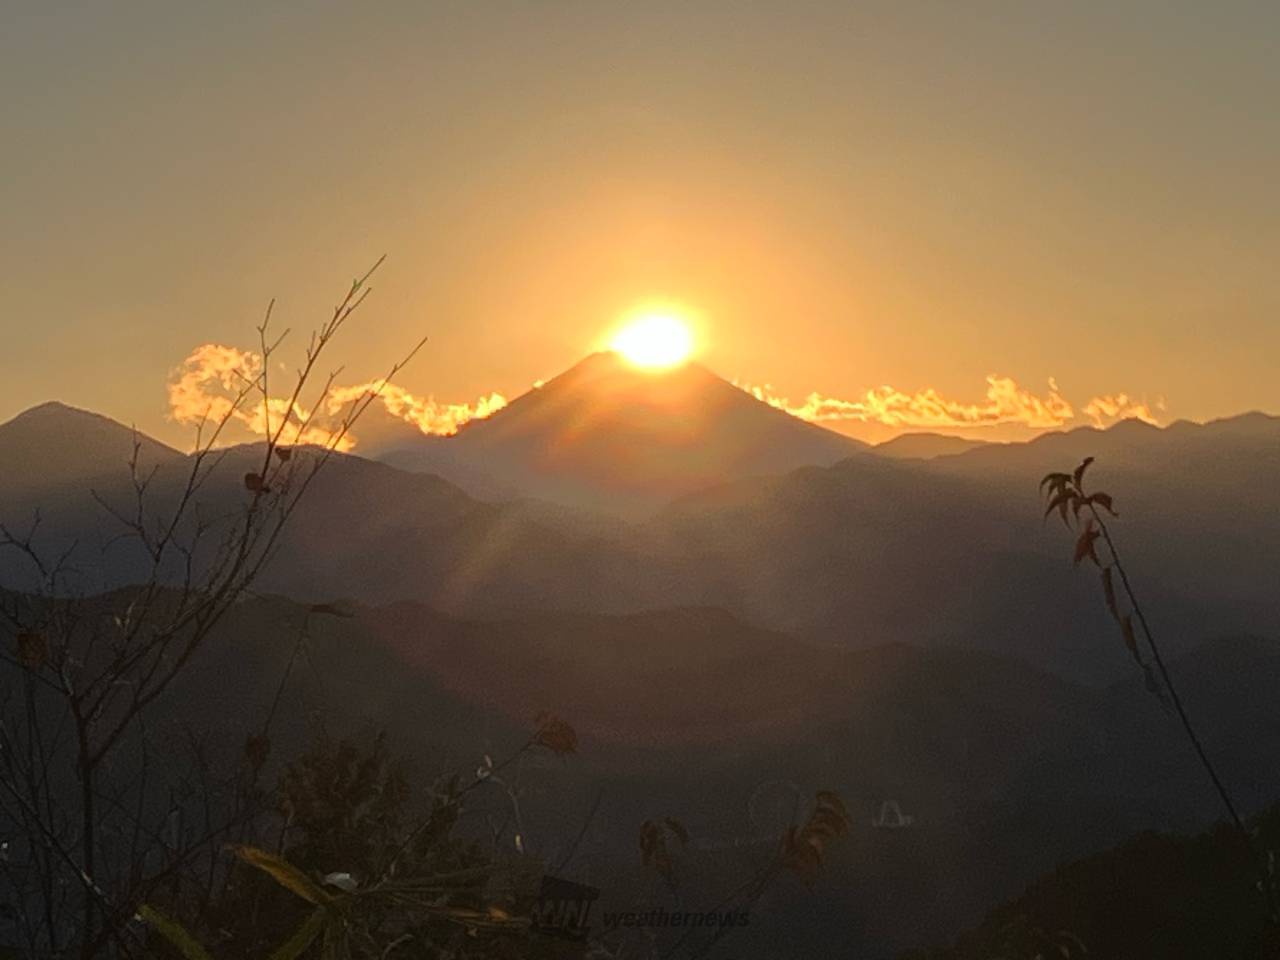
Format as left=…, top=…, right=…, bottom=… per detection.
left=0, top=0, right=1280, bottom=444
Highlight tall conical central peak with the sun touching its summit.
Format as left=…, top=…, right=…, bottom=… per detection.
left=380, top=353, right=869, bottom=517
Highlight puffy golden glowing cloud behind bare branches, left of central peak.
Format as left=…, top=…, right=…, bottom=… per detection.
left=168, top=343, right=507, bottom=452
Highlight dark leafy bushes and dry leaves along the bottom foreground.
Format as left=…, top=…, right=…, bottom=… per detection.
left=136, top=714, right=850, bottom=960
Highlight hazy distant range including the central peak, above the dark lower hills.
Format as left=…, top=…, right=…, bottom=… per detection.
left=0, top=355, right=1280, bottom=682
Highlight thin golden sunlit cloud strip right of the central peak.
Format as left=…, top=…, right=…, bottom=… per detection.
left=735, top=374, right=1162, bottom=430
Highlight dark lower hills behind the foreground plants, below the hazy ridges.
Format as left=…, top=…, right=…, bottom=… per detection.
left=64, top=600, right=1280, bottom=960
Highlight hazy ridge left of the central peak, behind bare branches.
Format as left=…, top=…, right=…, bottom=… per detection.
left=0, top=404, right=666, bottom=616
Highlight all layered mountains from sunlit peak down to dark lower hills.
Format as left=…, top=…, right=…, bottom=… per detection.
left=0, top=366, right=1280, bottom=957
